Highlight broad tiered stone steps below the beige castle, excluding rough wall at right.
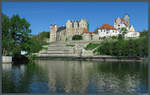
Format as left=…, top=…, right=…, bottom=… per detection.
left=36, top=42, right=76, bottom=57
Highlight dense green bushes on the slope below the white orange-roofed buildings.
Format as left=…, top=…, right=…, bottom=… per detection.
left=95, top=31, right=148, bottom=57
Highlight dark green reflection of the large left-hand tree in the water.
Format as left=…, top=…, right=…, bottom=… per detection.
left=2, top=60, right=48, bottom=93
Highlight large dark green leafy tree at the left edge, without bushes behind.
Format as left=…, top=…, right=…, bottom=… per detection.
left=2, top=14, right=31, bottom=56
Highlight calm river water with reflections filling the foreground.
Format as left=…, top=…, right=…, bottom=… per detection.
left=2, top=60, right=148, bottom=95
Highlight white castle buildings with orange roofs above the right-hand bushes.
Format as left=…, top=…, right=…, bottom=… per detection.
left=98, top=14, right=140, bottom=38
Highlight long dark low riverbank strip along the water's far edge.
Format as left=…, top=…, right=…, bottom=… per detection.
left=35, top=56, right=148, bottom=62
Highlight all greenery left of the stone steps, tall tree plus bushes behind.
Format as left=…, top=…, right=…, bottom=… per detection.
left=2, top=14, right=49, bottom=57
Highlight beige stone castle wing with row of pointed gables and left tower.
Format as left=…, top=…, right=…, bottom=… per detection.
left=50, top=19, right=91, bottom=42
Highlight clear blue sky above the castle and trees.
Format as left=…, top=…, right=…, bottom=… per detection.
left=2, top=2, right=148, bottom=34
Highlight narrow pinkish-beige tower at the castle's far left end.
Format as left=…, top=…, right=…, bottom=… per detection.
left=50, top=25, right=58, bottom=42
